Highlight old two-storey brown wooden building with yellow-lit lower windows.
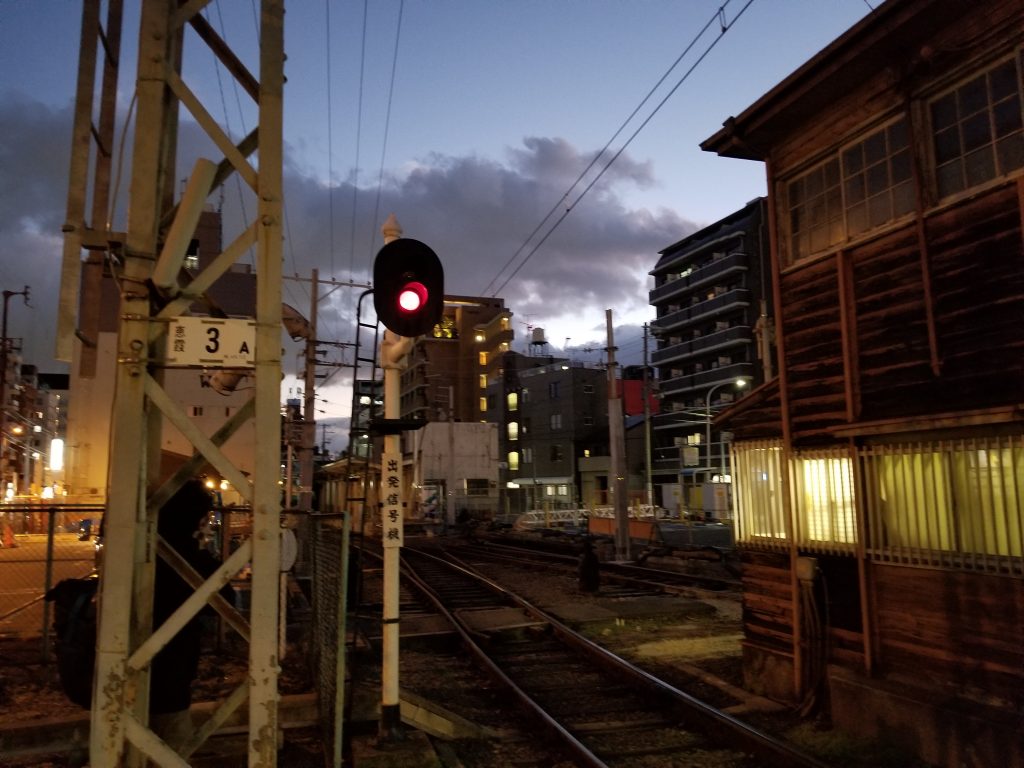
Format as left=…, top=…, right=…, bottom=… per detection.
left=701, top=0, right=1024, bottom=766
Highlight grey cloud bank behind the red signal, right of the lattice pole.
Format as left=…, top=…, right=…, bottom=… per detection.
left=266, top=137, right=696, bottom=360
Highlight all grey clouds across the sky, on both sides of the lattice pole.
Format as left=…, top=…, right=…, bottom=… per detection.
left=0, top=94, right=695, bottom=385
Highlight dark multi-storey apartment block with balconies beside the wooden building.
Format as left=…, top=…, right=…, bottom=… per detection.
left=650, top=198, right=774, bottom=518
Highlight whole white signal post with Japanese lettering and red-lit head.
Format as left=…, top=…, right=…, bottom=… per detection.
left=374, top=214, right=444, bottom=741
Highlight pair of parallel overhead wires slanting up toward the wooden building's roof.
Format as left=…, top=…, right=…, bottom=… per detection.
left=483, top=0, right=754, bottom=296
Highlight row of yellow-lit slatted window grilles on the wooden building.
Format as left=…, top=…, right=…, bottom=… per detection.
left=732, top=435, right=1024, bottom=575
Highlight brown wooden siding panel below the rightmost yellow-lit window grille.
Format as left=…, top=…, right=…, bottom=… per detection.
left=871, top=565, right=1024, bottom=707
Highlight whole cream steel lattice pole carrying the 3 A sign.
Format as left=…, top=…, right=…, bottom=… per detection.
left=76, top=0, right=284, bottom=768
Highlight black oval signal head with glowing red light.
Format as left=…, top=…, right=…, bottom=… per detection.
left=374, top=238, right=444, bottom=337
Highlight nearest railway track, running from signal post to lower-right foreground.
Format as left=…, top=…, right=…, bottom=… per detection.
left=393, top=548, right=824, bottom=768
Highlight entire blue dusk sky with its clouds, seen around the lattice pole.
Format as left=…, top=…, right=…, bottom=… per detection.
left=0, top=0, right=879, bottom=442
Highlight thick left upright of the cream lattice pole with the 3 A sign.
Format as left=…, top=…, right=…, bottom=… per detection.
left=90, top=0, right=178, bottom=768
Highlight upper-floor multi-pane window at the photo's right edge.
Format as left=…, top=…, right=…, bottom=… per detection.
left=930, top=59, right=1024, bottom=198
